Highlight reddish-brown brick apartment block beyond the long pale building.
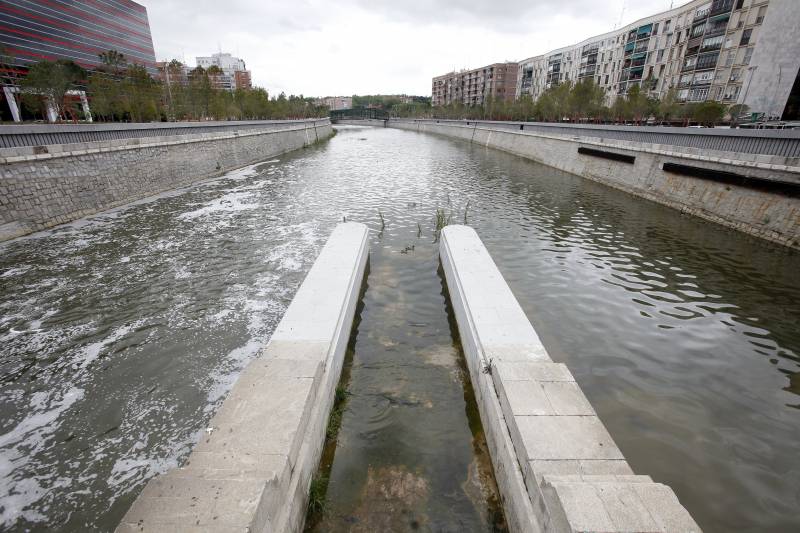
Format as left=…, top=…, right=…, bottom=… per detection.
left=431, top=62, right=517, bottom=106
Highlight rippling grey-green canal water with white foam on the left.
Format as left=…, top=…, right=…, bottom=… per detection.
left=0, top=123, right=800, bottom=532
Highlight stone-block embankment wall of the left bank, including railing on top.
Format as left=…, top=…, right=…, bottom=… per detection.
left=0, top=119, right=333, bottom=241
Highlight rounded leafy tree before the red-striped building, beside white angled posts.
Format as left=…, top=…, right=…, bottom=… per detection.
left=20, top=59, right=86, bottom=120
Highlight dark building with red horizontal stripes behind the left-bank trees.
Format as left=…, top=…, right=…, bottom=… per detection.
left=0, top=0, right=158, bottom=76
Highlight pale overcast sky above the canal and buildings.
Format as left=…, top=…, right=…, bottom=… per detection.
left=138, top=0, right=688, bottom=96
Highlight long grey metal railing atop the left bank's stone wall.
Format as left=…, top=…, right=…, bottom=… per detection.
left=0, top=118, right=330, bottom=149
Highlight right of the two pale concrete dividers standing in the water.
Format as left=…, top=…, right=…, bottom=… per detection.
left=440, top=226, right=700, bottom=533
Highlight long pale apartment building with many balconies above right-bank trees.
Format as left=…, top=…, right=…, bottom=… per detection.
left=512, top=0, right=800, bottom=119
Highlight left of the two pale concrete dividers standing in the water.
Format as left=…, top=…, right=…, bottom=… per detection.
left=117, top=222, right=369, bottom=533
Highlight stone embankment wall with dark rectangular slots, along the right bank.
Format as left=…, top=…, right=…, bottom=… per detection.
left=388, top=119, right=800, bottom=249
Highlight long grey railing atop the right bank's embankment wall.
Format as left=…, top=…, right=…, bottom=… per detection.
left=391, top=119, right=800, bottom=158
